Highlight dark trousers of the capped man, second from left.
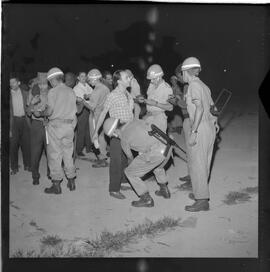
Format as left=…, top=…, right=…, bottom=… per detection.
left=30, top=119, right=48, bottom=179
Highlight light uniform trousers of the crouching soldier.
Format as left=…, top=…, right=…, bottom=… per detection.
left=125, top=145, right=170, bottom=196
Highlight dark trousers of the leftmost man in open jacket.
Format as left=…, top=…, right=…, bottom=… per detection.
left=10, top=116, right=31, bottom=170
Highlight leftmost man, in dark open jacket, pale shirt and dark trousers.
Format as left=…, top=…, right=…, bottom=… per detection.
left=9, top=75, right=31, bottom=175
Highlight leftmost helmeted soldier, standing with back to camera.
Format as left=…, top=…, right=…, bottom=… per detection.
left=44, top=68, right=77, bottom=194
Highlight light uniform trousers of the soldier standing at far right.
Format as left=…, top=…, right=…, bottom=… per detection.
left=189, top=120, right=216, bottom=199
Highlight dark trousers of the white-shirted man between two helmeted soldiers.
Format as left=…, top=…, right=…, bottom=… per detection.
left=76, top=108, right=91, bottom=154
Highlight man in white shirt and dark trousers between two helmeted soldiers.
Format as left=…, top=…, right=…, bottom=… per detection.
left=73, top=72, right=93, bottom=157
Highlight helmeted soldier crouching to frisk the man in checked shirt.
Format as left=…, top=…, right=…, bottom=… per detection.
left=103, top=118, right=171, bottom=207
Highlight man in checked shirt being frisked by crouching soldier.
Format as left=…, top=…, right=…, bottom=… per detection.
left=93, top=70, right=134, bottom=199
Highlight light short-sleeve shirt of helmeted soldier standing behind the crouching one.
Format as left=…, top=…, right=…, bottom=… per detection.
left=147, top=81, right=173, bottom=112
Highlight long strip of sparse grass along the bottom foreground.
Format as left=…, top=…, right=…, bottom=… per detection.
left=12, top=217, right=181, bottom=258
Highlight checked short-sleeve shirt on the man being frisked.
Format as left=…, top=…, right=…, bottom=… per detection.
left=104, top=87, right=134, bottom=123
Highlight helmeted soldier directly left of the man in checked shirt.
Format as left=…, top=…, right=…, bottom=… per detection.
left=84, top=69, right=110, bottom=168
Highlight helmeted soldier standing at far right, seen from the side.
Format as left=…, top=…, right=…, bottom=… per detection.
left=182, top=57, right=216, bottom=212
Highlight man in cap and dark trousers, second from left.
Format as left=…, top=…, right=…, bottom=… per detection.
left=28, top=73, right=49, bottom=185
